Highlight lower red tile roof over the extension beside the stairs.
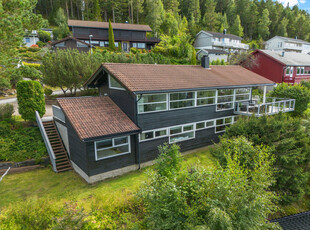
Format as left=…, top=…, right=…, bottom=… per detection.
left=57, top=96, right=139, bottom=140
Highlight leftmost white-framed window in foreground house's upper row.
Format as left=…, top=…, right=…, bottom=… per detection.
left=138, top=93, right=168, bottom=114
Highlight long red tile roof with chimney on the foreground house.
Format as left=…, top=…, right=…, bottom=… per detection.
left=84, top=63, right=274, bottom=92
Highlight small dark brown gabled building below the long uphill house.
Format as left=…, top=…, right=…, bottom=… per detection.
left=51, top=36, right=94, bottom=52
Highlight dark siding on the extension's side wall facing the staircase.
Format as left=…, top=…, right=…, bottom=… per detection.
left=66, top=117, right=89, bottom=175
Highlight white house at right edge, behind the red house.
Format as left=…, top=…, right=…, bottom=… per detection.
left=265, top=36, right=310, bottom=53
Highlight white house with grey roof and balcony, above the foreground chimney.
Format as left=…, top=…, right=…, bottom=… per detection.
left=194, top=30, right=249, bottom=53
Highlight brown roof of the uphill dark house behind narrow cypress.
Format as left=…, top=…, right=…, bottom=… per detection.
left=68, top=20, right=152, bottom=32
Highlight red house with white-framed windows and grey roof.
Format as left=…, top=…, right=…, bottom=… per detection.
left=242, top=50, right=310, bottom=84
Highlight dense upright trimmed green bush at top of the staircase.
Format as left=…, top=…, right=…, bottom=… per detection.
left=16, top=80, right=45, bottom=121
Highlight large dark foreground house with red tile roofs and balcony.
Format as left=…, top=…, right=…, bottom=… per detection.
left=37, top=58, right=295, bottom=183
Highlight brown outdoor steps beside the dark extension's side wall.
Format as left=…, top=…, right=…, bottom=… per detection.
left=42, top=121, right=72, bottom=172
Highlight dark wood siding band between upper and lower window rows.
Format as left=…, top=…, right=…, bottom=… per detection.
left=137, top=105, right=233, bottom=131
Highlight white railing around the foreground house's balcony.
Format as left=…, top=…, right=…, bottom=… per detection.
left=234, top=97, right=295, bottom=117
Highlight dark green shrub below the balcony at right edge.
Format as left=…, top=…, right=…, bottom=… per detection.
left=223, top=114, right=310, bottom=204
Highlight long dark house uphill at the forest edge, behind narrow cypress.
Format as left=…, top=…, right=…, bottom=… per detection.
left=68, top=20, right=160, bottom=51
